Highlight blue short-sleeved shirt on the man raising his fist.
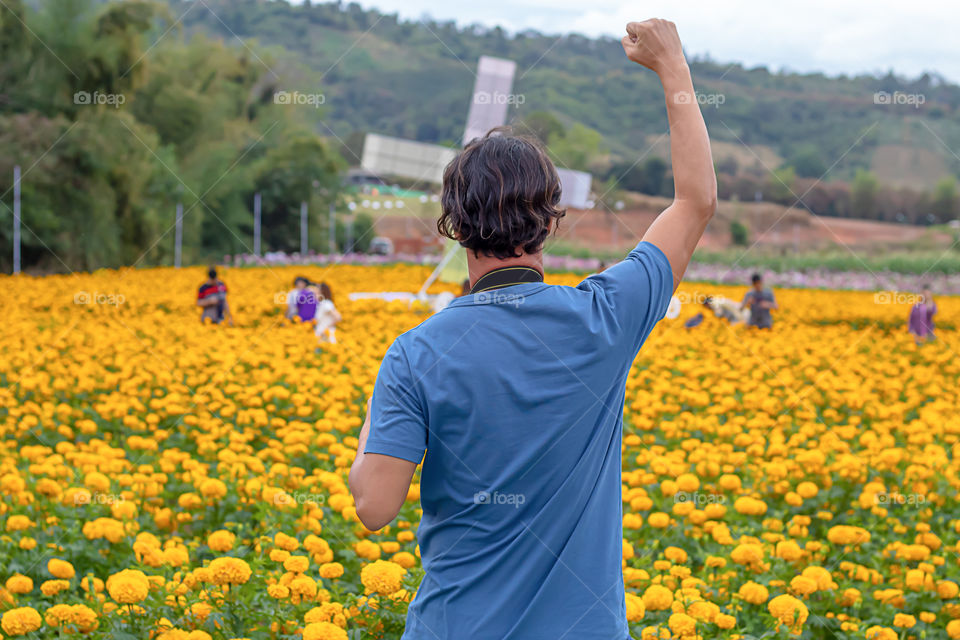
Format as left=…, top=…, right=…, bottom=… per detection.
left=364, top=242, right=673, bottom=640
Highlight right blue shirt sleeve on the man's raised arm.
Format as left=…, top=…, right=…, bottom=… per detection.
left=580, top=242, right=673, bottom=354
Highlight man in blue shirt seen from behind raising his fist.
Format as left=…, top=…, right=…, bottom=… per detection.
left=350, top=20, right=716, bottom=640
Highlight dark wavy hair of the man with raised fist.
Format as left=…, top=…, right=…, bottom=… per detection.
left=437, top=127, right=566, bottom=259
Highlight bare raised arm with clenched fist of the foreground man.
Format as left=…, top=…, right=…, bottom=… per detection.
left=623, top=19, right=717, bottom=289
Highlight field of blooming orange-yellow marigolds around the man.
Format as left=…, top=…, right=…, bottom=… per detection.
left=0, top=265, right=960, bottom=640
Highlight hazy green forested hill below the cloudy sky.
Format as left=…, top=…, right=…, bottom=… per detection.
left=171, top=0, right=960, bottom=190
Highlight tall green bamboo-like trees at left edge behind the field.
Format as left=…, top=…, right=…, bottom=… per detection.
left=0, top=0, right=343, bottom=271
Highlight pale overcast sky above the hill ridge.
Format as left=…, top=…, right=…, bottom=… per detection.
left=360, top=0, right=960, bottom=82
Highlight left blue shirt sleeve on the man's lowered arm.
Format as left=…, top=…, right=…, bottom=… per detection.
left=363, top=342, right=427, bottom=463
